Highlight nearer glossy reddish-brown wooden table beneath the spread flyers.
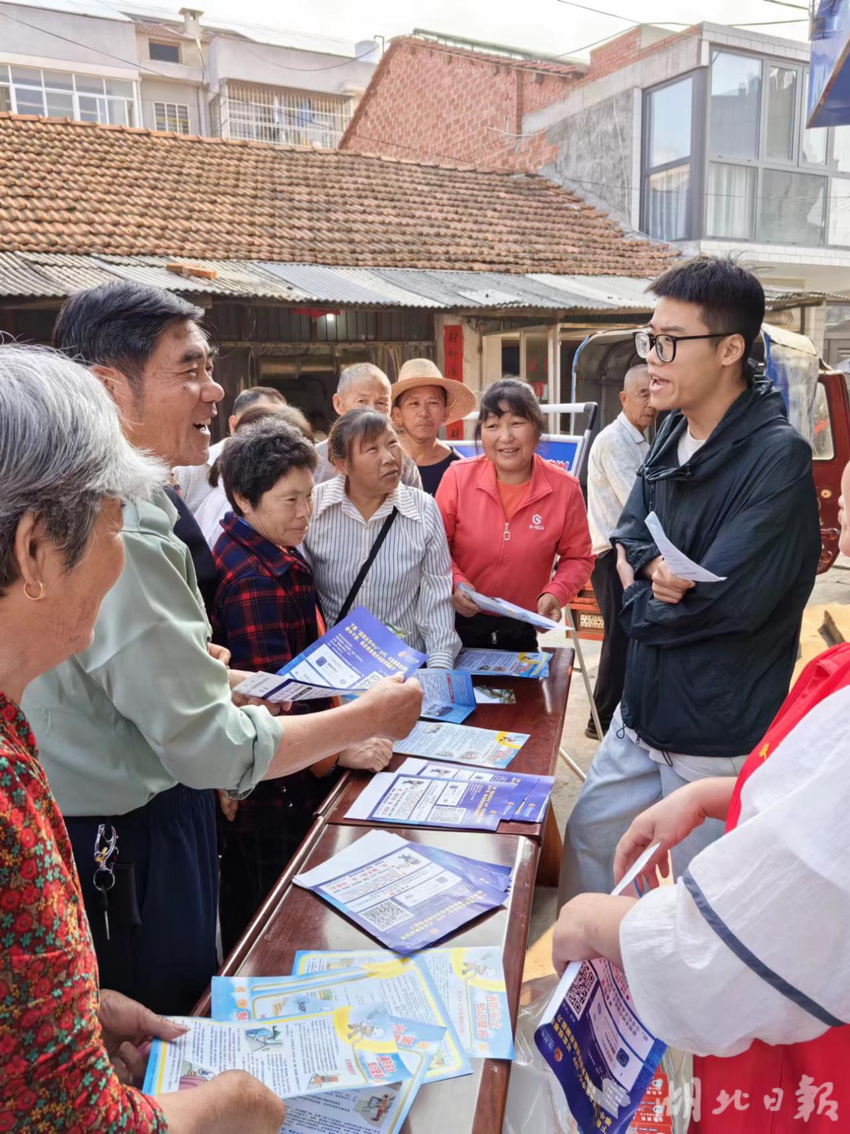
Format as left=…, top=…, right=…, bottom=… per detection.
left=195, top=819, right=541, bottom=1134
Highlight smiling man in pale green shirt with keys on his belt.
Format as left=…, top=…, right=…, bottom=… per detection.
left=24, top=284, right=422, bottom=1013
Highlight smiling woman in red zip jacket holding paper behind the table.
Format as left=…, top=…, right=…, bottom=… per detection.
left=436, top=378, right=594, bottom=651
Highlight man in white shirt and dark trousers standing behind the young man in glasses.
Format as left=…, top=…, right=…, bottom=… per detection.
left=585, top=364, right=655, bottom=741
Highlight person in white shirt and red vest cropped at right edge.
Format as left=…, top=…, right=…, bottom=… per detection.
left=554, top=455, right=850, bottom=1134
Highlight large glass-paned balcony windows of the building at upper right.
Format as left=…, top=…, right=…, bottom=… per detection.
left=643, top=48, right=850, bottom=246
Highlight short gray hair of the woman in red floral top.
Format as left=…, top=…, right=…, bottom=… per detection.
left=0, top=345, right=167, bottom=594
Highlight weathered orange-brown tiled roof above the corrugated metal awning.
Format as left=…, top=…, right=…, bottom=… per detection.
left=0, top=113, right=677, bottom=277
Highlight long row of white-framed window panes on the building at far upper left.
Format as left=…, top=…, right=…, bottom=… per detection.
left=0, top=64, right=136, bottom=126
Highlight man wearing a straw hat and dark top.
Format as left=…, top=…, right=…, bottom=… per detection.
left=392, top=358, right=477, bottom=496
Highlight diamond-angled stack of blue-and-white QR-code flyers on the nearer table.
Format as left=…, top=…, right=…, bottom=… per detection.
left=294, top=831, right=511, bottom=954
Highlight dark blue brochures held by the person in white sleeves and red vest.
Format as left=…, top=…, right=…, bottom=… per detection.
left=534, top=844, right=666, bottom=1134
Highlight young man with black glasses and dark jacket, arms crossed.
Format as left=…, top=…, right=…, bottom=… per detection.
left=560, top=256, right=821, bottom=904
